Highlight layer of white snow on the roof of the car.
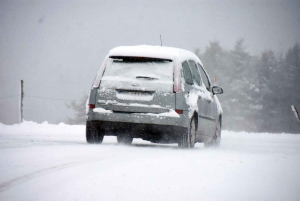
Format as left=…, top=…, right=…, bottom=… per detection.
left=108, top=45, right=202, bottom=65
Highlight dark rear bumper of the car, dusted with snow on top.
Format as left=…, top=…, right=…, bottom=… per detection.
left=87, top=110, right=188, bottom=143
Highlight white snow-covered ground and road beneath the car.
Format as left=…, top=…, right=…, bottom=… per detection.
left=0, top=122, right=300, bottom=201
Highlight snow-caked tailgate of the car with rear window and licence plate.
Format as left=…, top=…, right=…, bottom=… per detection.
left=97, top=57, right=175, bottom=113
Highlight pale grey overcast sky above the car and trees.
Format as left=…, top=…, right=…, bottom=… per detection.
left=0, top=0, right=300, bottom=124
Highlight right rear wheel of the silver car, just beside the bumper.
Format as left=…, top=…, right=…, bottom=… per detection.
left=178, top=117, right=197, bottom=149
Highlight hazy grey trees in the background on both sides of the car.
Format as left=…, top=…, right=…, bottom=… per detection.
left=68, top=39, right=300, bottom=133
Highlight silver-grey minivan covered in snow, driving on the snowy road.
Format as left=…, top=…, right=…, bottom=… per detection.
left=86, top=45, right=223, bottom=148
